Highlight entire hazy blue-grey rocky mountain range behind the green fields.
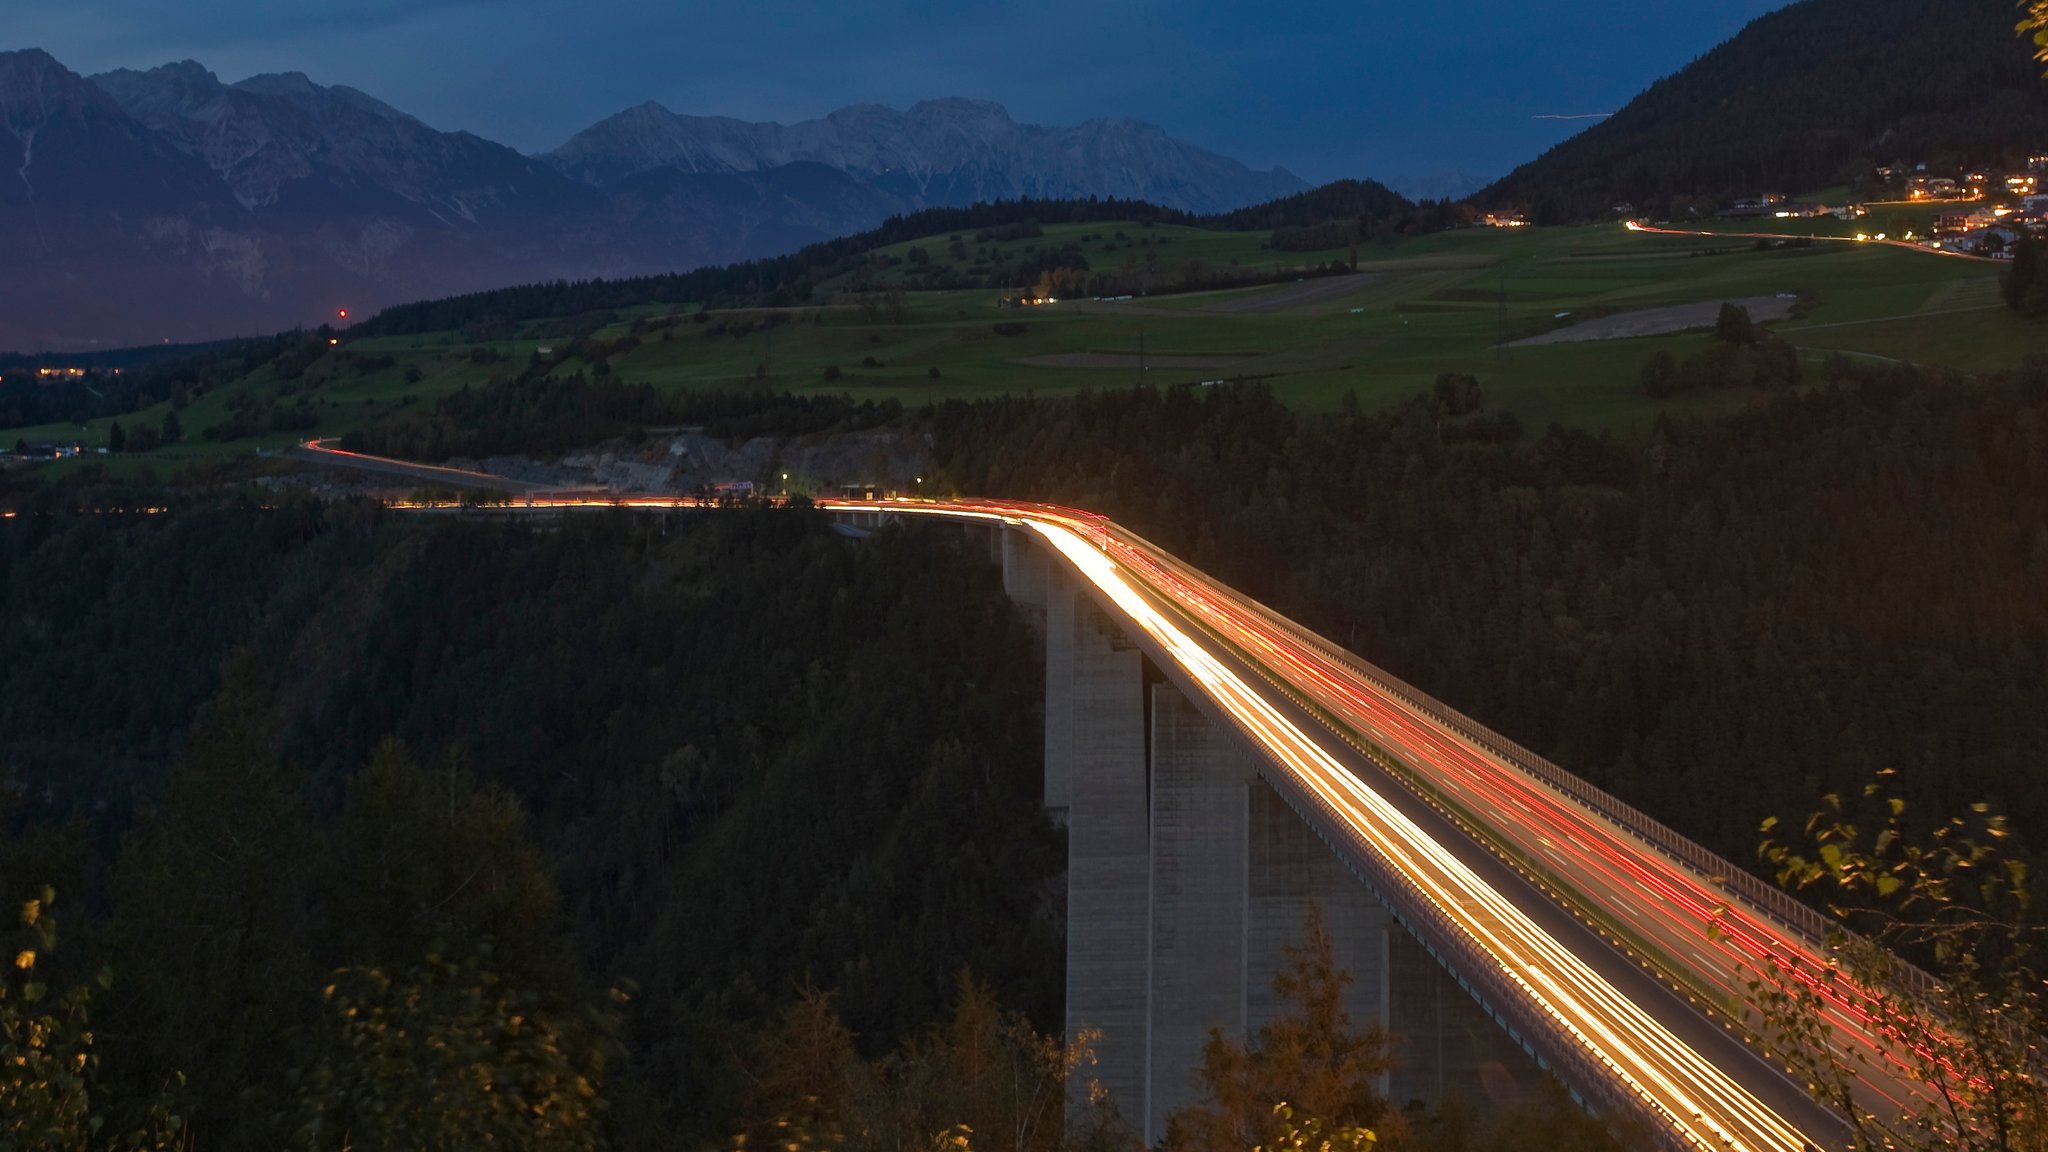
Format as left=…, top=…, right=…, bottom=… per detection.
left=0, top=49, right=1307, bottom=351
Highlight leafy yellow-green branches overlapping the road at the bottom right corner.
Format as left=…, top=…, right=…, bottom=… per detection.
left=1749, top=773, right=2048, bottom=1152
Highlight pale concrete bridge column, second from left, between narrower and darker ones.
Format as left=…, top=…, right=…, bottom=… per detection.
left=1130, top=685, right=1266, bottom=1148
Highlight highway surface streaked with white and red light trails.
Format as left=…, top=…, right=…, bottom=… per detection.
left=307, top=445, right=1913, bottom=1152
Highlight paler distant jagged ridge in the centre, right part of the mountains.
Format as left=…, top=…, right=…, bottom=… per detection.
left=545, top=98, right=1309, bottom=213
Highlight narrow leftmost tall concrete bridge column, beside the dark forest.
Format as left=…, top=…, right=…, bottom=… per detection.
left=1047, top=594, right=1149, bottom=1123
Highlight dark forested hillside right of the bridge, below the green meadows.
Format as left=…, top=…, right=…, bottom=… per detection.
left=936, top=363, right=2048, bottom=861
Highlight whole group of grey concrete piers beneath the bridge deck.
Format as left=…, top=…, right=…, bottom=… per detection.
left=999, top=531, right=1536, bottom=1146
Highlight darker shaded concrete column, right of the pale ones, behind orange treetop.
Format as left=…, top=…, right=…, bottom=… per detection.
left=1245, top=783, right=1393, bottom=1031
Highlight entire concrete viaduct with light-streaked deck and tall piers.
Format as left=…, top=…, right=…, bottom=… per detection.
left=305, top=445, right=1913, bottom=1152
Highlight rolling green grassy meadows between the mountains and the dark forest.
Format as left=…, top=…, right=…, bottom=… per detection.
left=0, top=223, right=2042, bottom=455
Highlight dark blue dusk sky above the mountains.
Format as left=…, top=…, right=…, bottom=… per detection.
left=24, top=0, right=1786, bottom=180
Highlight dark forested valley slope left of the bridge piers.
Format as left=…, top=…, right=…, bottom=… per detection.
left=0, top=504, right=1063, bottom=1150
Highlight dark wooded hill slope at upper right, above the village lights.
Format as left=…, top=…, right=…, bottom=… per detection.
left=1481, top=0, right=2048, bottom=219
